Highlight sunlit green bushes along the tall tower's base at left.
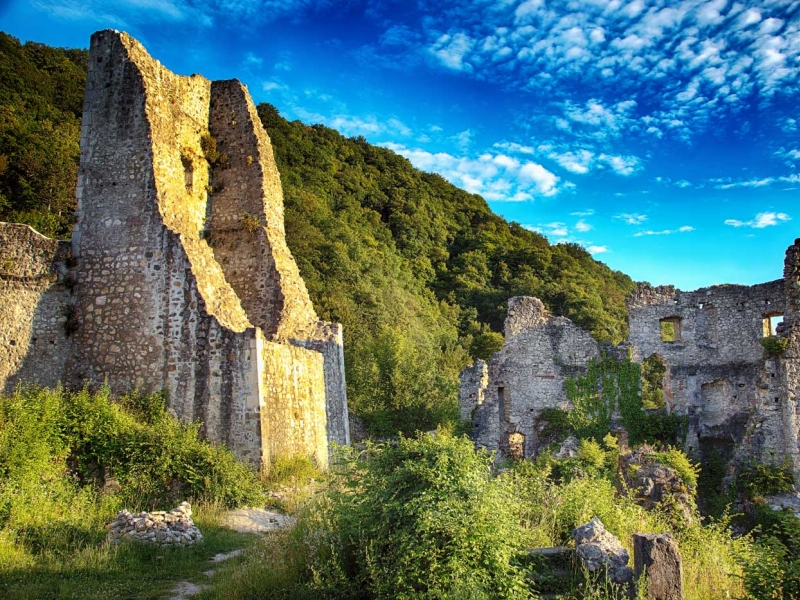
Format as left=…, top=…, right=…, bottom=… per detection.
left=0, top=389, right=263, bottom=520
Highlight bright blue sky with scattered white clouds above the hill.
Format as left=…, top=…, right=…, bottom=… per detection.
left=0, top=0, right=800, bottom=290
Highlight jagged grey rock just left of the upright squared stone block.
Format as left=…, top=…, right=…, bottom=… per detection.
left=572, top=517, right=633, bottom=590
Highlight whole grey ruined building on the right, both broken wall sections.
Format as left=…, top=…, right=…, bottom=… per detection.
left=459, top=239, right=800, bottom=475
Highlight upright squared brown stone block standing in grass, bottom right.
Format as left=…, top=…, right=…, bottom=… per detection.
left=633, top=533, right=683, bottom=600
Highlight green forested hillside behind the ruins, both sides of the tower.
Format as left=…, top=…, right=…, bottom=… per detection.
left=0, top=34, right=633, bottom=433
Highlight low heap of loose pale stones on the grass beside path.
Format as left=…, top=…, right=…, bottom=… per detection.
left=108, top=502, right=203, bottom=546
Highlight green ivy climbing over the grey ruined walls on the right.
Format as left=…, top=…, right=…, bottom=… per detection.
left=565, top=354, right=682, bottom=445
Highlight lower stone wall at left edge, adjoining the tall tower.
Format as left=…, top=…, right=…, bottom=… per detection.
left=0, top=223, right=73, bottom=394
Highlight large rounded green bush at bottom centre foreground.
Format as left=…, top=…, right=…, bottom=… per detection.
left=298, top=429, right=528, bottom=598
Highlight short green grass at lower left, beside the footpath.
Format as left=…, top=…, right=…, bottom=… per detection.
left=0, top=507, right=259, bottom=600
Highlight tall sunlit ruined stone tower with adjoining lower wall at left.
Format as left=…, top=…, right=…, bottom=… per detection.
left=0, top=30, right=349, bottom=466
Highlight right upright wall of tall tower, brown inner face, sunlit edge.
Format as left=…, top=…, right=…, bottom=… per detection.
left=205, top=80, right=350, bottom=445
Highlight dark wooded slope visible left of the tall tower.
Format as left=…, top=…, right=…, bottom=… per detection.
left=0, top=32, right=87, bottom=237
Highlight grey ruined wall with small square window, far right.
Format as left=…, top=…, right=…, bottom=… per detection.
left=628, top=280, right=787, bottom=464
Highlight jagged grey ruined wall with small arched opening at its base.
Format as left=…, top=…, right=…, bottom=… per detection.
left=471, top=297, right=600, bottom=456
